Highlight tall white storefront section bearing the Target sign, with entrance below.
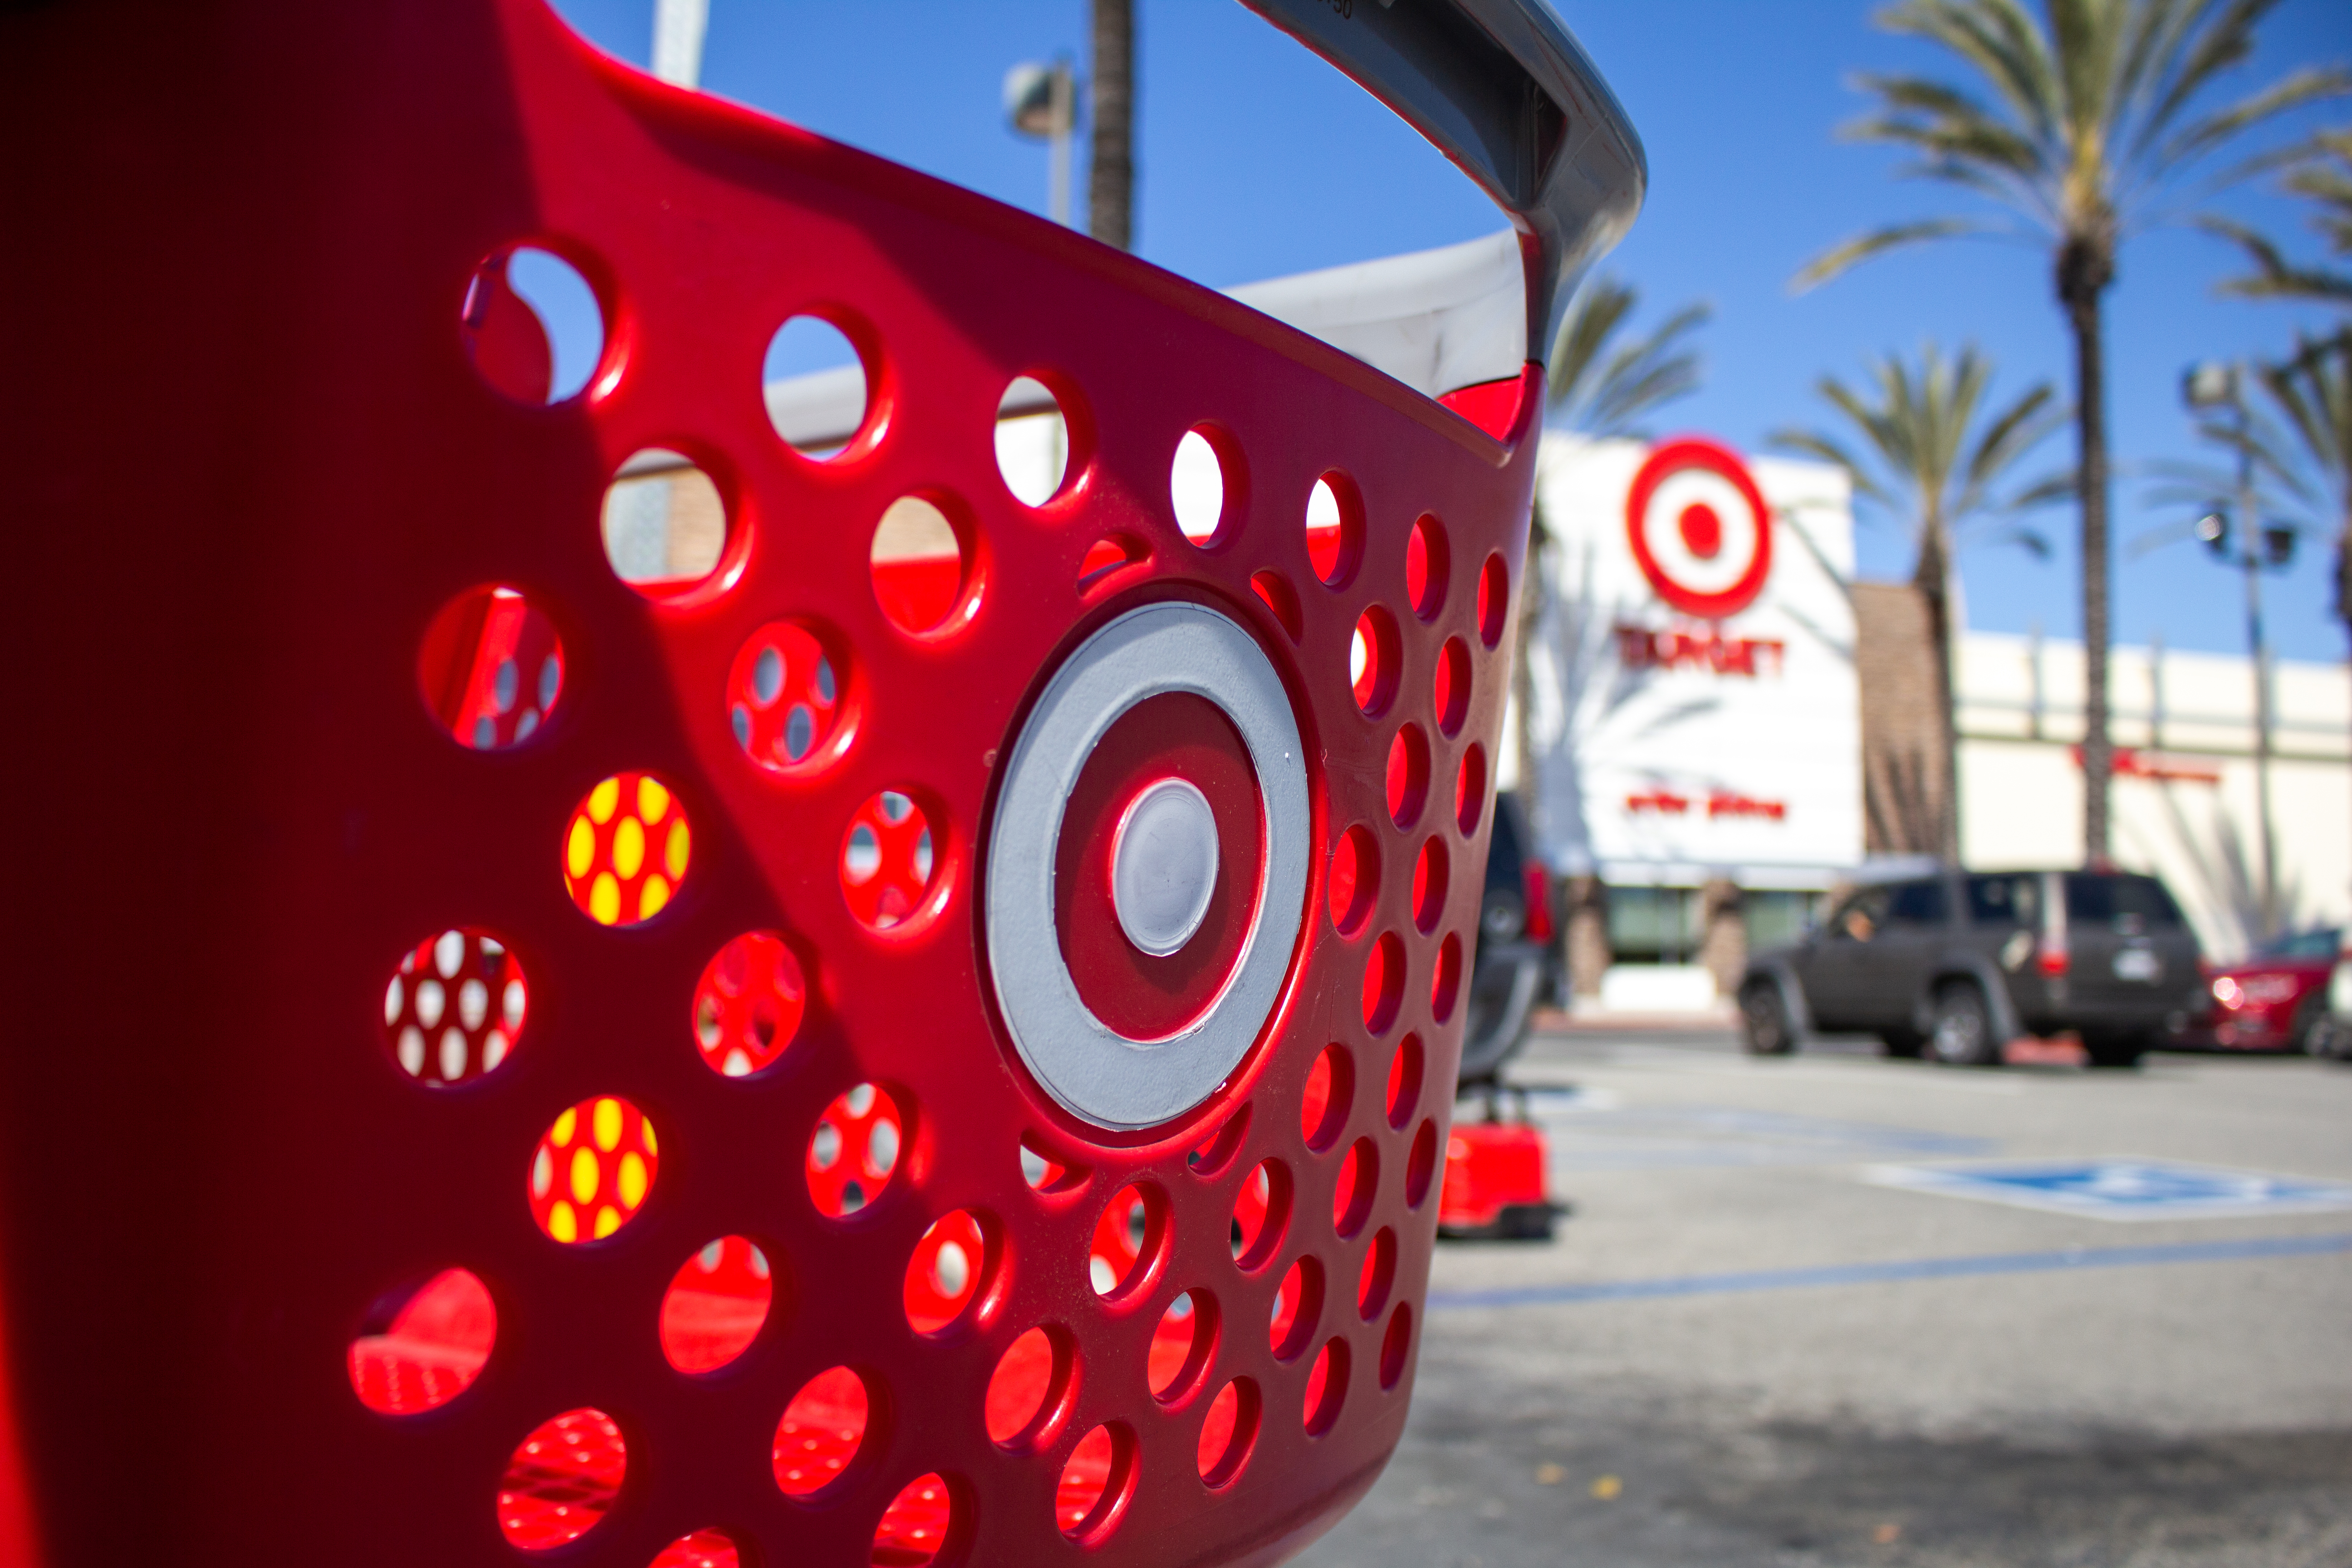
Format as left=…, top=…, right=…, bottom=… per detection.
left=1503, top=432, right=1865, bottom=1013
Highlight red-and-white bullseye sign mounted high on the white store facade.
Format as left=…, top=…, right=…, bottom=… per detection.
left=1625, top=440, right=1771, bottom=621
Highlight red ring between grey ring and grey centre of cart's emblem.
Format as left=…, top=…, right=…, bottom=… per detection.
left=1054, top=691, right=1265, bottom=1039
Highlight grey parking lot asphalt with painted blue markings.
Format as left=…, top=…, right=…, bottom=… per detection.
left=1298, top=1029, right=2352, bottom=1568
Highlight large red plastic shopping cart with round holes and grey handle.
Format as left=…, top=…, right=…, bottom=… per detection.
left=0, top=0, right=1642, bottom=1568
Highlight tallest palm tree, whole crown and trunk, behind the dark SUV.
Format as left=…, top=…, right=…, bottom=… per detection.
left=1797, top=0, right=2352, bottom=863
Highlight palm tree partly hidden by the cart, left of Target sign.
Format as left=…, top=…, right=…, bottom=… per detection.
left=1510, top=275, right=1715, bottom=778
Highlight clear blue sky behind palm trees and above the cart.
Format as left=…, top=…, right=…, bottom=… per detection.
left=558, top=0, right=2352, bottom=661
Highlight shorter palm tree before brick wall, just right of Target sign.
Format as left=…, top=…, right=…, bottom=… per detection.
left=1769, top=343, right=2074, bottom=860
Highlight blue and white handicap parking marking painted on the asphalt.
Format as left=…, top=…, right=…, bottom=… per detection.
left=1863, top=1159, right=2352, bottom=1220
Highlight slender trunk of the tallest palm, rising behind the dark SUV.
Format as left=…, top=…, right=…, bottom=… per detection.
left=2058, top=240, right=2114, bottom=865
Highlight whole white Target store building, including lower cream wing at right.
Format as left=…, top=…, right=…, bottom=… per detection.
left=1505, top=432, right=2352, bottom=1013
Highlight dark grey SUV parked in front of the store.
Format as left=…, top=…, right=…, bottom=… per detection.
left=1740, top=870, right=2204, bottom=1067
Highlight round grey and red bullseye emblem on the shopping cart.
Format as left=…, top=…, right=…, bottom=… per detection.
left=985, top=602, right=1310, bottom=1131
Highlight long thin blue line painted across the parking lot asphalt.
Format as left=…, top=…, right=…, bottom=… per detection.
left=1430, top=1232, right=2352, bottom=1312
